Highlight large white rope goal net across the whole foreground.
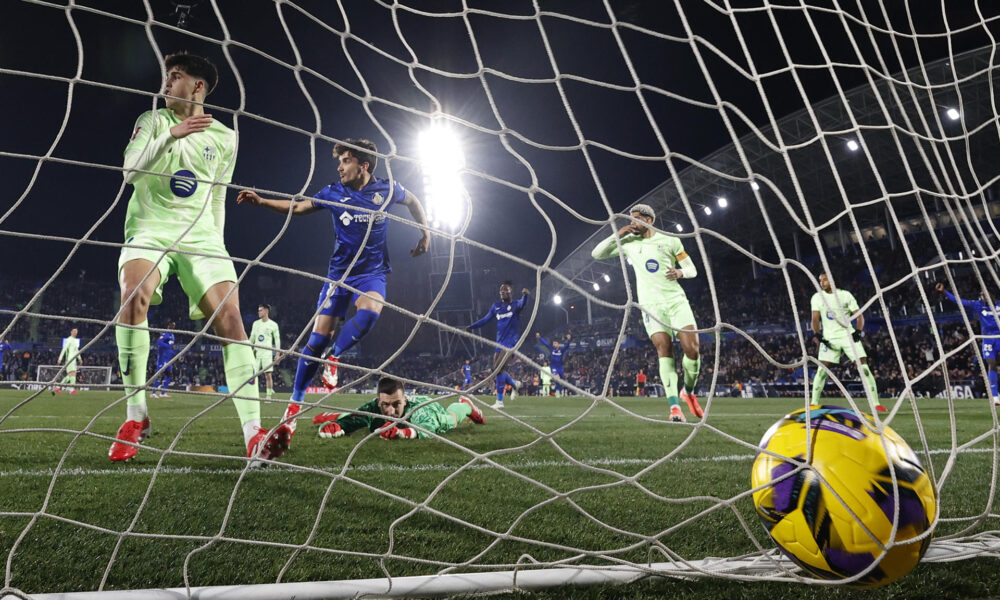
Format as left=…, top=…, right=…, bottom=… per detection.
left=0, top=0, right=1000, bottom=599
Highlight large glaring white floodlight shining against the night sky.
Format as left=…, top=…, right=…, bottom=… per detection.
left=419, top=124, right=466, bottom=231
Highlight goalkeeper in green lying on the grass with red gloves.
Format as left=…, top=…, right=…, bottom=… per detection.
left=313, top=377, right=486, bottom=440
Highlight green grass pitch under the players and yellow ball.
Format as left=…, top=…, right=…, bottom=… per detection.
left=0, top=391, right=1000, bottom=599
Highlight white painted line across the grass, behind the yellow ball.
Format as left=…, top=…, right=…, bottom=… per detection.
left=0, top=448, right=993, bottom=478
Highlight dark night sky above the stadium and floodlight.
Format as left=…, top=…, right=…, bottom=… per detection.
left=0, top=0, right=997, bottom=292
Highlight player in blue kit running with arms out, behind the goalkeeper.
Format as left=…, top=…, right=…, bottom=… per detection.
left=243, top=139, right=431, bottom=440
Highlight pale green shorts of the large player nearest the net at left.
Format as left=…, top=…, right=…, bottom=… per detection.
left=118, top=233, right=236, bottom=320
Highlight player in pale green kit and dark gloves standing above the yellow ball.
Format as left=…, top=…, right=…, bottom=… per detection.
left=810, top=273, right=886, bottom=412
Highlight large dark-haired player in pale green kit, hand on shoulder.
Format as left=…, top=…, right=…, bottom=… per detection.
left=108, top=53, right=290, bottom=461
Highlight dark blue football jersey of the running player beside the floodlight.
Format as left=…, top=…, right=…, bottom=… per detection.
left=313, top=177, right=406, bottom=279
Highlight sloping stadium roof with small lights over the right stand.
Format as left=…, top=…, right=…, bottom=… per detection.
left=541, top=47, right=1000, bottom=303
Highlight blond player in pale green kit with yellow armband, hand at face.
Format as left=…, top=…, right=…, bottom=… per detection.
left=591, top=204, right=704, bottom=422
